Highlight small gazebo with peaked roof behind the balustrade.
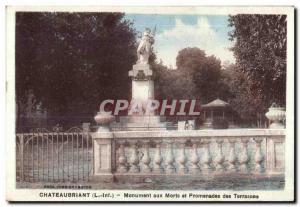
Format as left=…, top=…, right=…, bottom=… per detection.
left=201, top=98, right=231, bottom=128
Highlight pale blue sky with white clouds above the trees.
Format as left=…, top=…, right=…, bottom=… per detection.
left=125, top=14, right=235, bottom=68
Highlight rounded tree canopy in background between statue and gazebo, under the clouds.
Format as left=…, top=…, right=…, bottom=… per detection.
left=152, top=47, right=230, bottom=104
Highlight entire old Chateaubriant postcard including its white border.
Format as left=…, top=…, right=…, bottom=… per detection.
left=5, top=6, right=295, bottom=202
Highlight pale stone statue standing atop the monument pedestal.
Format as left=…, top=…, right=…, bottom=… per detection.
left=137, top=28, right=155, bottom=64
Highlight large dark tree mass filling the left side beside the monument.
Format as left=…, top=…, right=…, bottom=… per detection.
left=16, top=12, right=136, bottom=128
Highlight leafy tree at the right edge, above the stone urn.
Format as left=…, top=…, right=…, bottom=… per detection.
left=229, top=14, right=287, bottom=113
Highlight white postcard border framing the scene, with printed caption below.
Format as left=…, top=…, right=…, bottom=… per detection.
left=5, top=6, right=295, bottom=202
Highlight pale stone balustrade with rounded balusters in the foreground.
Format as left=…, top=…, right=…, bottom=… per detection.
left=92, top=129, right=285, bottom=179
